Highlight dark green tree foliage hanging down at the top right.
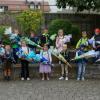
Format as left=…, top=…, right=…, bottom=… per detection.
left=56, top=0, right=100, bottom=11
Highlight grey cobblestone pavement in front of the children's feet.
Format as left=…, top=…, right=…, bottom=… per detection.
left=0, top=79, right=100, bottom=100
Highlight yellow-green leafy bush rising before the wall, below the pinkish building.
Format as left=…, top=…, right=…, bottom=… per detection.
left=16, top=10, right=43, bottom=34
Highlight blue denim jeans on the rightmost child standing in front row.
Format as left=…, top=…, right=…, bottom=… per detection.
left=77, top=62, right=86, bottom=79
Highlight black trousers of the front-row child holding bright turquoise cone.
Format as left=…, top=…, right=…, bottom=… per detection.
left=21, top=60, right=29, bottom=78
